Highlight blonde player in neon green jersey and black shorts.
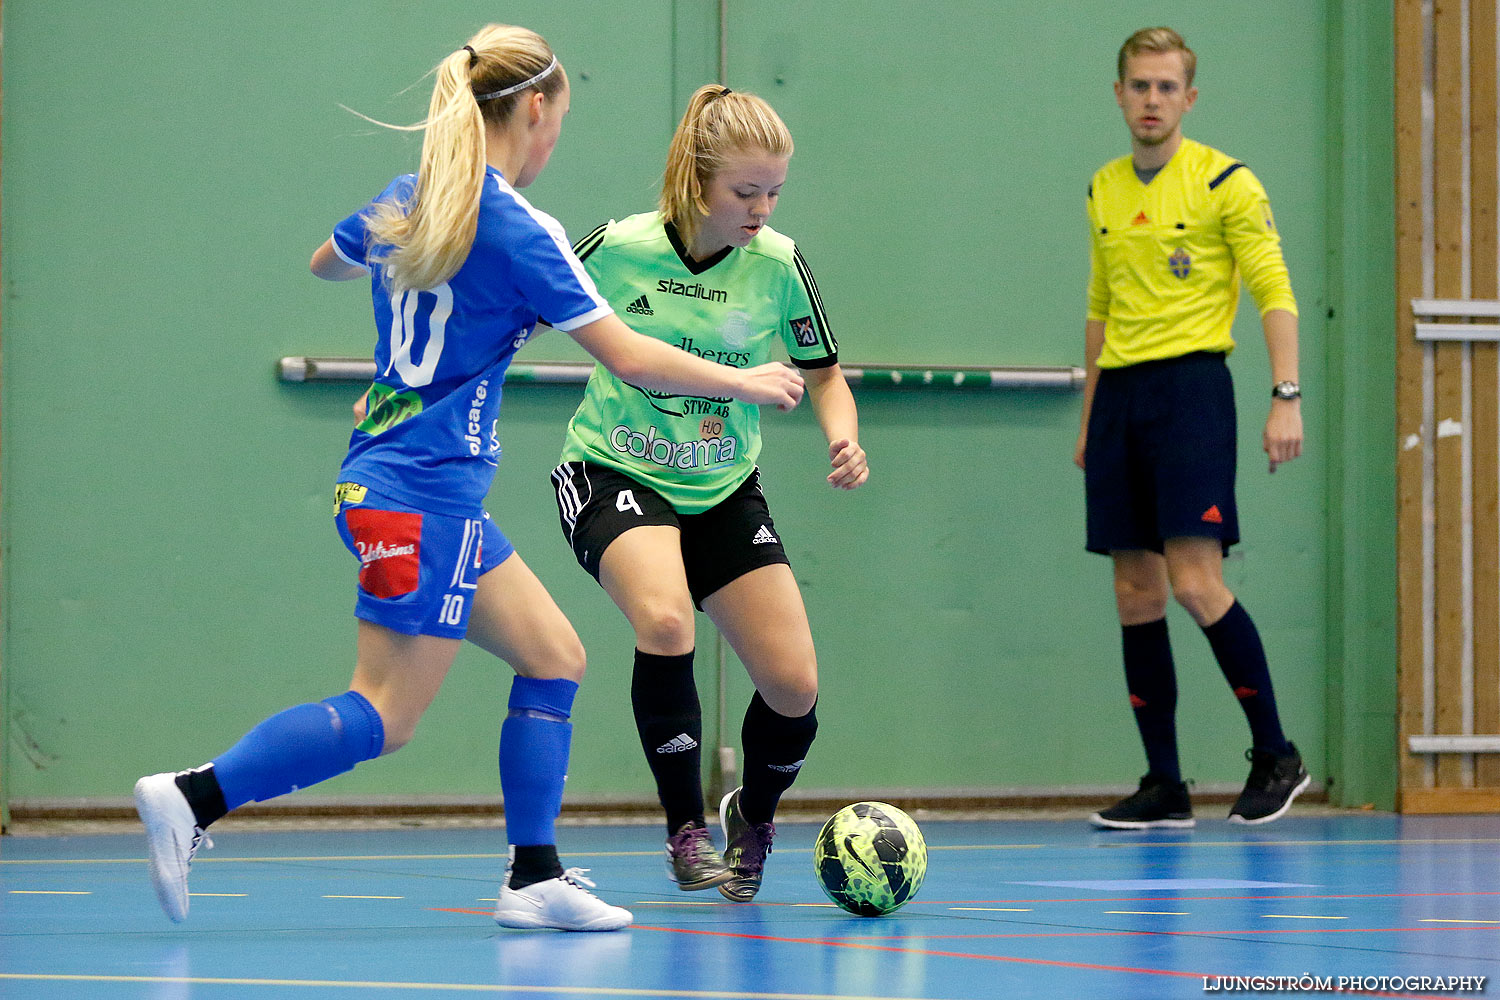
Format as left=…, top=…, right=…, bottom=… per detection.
left=552, top=84, right=869, bottom=903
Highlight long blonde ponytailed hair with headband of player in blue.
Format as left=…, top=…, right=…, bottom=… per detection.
left=368, top=24, right=567, bottom=292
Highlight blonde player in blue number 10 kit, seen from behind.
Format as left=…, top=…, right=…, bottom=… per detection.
left=135, top=25, right=801, bottom=931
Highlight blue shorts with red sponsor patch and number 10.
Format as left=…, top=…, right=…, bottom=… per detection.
left=333, top=483, right=516, bottom=639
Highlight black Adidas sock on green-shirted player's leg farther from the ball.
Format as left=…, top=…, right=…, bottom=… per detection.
left=630, top=649, right=704, bottom=837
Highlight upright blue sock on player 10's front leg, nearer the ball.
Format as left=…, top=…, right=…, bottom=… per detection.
left=500, top=676, right=578, bottom=846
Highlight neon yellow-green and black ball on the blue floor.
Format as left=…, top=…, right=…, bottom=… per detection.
left=813, top=802, right=927, bottom=916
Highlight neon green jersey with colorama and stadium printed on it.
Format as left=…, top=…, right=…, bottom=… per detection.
left=563, top=213, right=839, bottom=514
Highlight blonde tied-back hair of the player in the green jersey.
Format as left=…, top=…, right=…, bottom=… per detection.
left=660, top=84, right=792, bottom=246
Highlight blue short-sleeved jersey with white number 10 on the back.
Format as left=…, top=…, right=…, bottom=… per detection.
left=333, top=166, right=614, bottom=517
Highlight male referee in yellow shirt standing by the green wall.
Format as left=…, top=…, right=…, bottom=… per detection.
left=1074, top=27, right=1310, bottom=829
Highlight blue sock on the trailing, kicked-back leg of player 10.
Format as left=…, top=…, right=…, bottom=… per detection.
left=213, top=691, right=386, bottom=810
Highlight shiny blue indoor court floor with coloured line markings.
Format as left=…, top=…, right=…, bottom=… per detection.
left=0, top=810, right=1500, bottom=1000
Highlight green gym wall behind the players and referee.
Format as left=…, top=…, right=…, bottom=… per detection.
left=0, top=0, right=1395, bottom=808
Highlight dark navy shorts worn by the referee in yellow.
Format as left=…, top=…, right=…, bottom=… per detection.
left=1083, top=352, right=1239, bottom=553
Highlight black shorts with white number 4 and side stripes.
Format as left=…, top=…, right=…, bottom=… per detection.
left=552, top=462, right=791, bottom=609
